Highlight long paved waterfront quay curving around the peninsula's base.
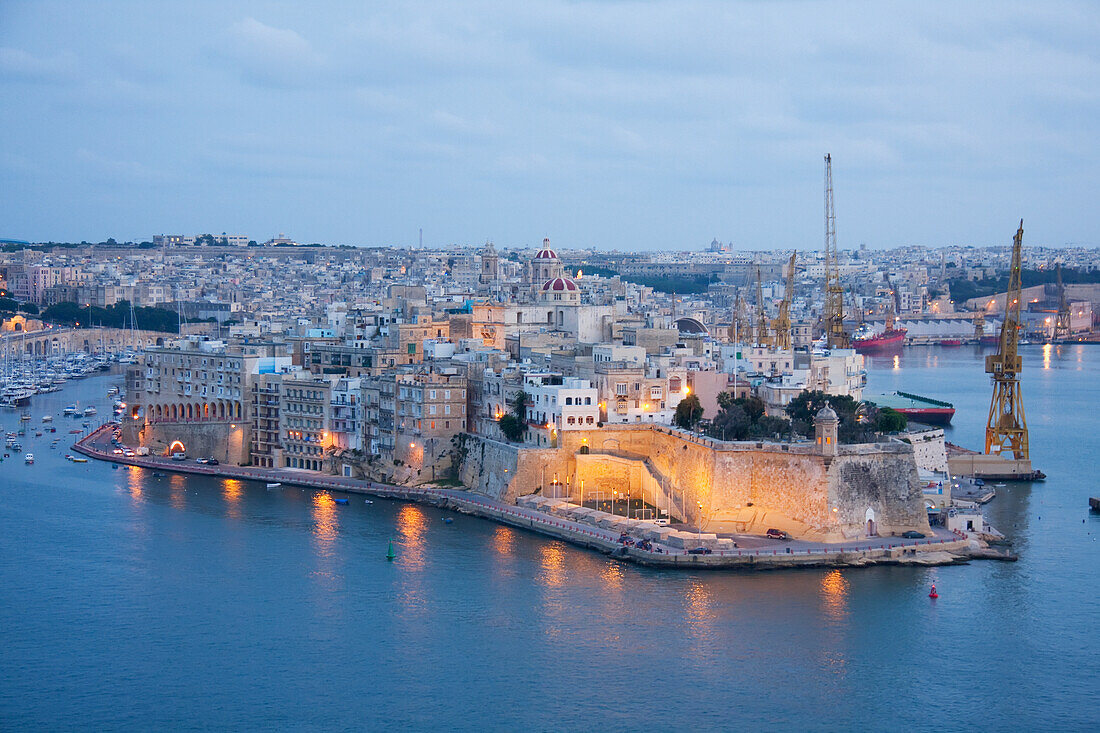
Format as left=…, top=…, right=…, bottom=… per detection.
left=73, top=423, right=1015, bottom=569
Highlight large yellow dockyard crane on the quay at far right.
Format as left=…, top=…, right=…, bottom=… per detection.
left=986, top=219, right=1030, bottom=460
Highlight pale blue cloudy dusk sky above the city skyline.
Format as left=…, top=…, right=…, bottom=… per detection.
left=0, top=0, right=1100, bottom=251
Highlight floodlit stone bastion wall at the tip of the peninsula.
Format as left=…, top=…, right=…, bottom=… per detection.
left=460, top=426, right=928, bottom=540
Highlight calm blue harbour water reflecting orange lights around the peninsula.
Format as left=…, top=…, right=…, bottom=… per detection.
left=0, top=347, right=1100, bottom=731
